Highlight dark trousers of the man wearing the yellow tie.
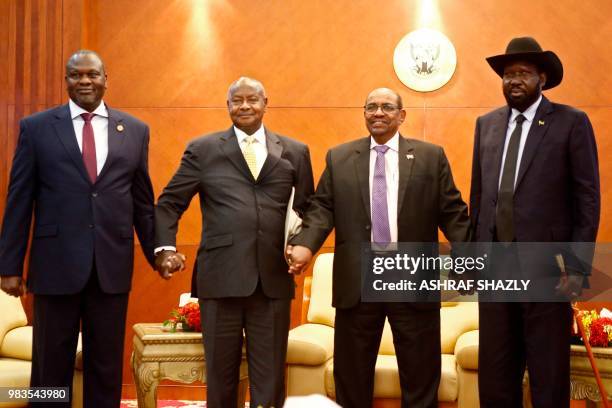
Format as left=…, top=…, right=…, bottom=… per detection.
left=200, top=286, right=291, bottom=408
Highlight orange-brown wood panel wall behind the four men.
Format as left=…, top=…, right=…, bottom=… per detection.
left=0, top=0, right=612, bottom=398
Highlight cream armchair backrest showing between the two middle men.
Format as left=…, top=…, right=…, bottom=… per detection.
left=307, top=253, right=336, bottom=327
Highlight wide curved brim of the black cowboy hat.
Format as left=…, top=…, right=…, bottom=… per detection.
left=487, top=51, right=563, bottom=89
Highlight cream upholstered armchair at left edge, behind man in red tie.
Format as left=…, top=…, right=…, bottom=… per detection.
left=0, top=291, right=83, bottom=408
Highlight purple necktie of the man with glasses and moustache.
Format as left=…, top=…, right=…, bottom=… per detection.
left=372, top=145, right=391, bottom=244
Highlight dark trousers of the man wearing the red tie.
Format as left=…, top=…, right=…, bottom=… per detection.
left=30, top=271, right=128, bottom=408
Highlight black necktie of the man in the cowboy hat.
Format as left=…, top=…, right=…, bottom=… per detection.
left=495, top=115, right=525, bottom=242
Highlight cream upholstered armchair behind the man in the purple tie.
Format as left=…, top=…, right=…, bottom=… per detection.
left=287, top=254, right=479, bottom=408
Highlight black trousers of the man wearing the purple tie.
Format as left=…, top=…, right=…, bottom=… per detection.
left=334, top=303, right=441, bottom=408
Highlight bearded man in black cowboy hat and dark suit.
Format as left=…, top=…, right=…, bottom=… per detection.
left=470, top=37, right=600, bottom=408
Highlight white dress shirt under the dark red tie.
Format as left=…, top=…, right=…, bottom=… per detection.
left=68, top=99, right=108, bottom=174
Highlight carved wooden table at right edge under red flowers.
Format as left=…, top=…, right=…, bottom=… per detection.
left=570, top=345, right=612, bottom=407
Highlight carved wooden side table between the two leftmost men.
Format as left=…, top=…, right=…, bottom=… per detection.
left=131, top=323, right=248, bottom=408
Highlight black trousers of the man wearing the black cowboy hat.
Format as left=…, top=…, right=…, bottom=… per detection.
left=478, top=303, right=572, bottom=408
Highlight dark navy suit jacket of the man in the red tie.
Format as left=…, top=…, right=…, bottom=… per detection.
left=0, top=105, right=154, bottom=295
